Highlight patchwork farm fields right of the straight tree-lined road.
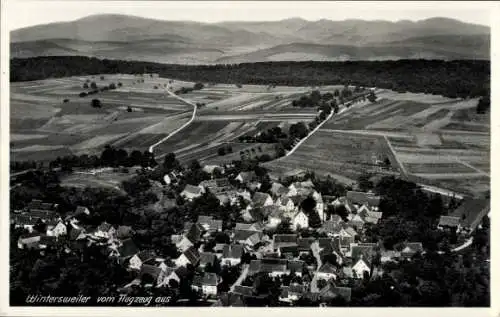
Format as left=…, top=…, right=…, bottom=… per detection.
left=266, top=91, right=490, bottom=196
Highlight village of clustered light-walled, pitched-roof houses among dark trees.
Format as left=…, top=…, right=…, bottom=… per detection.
left=11, top=157, right=489, bottom=306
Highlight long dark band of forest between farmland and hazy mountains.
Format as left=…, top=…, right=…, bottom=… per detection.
left=10, top=56, right=490, bottom=98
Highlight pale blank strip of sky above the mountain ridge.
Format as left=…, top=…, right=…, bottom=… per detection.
left=6, top=0, right=496, bottom=30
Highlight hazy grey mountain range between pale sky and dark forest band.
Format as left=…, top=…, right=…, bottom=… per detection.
left=10, top=14, right=490, bottom=64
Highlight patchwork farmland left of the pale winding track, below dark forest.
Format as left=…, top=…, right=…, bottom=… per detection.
left=10, top=75, right=192, bottom=161
